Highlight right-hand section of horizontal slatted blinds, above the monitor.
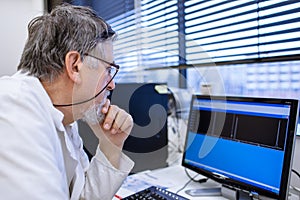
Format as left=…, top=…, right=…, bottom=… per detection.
left=184, top=0, right=300, bottom=64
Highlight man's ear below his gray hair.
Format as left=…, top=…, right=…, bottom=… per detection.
left=65, top=51, right=82, bottom=83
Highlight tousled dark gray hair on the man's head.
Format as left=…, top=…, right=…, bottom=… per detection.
left=18, top=4, right=115, bottom=81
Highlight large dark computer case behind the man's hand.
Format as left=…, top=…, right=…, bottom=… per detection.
left=79, top=83, right=168, bottom=173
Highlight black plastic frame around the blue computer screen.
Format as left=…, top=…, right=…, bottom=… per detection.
left=181, top=94, right=299, bottom=200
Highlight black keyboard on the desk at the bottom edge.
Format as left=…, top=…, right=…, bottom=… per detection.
left=122, top=186, right=188, bottom=200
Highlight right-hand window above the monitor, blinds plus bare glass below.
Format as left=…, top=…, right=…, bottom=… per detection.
left=184, top=0, right=300, bottom=98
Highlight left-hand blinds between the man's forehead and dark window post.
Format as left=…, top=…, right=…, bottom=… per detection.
left=108, top=0, right=179, bottom=82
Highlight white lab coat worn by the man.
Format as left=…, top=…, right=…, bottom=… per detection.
left=0, top=72, right=133, bottom=200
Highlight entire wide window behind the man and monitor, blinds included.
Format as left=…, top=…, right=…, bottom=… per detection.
left=69, top=0, right=300, bottom=98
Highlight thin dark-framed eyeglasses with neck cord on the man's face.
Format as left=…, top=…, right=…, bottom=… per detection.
left=53, top=53, right=120, bottom=107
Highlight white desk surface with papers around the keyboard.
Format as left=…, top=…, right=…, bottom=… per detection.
left=114, top=165, right=226, bottom=200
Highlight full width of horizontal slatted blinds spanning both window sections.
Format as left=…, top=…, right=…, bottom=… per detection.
left=74, top=0, right=300, bottom=71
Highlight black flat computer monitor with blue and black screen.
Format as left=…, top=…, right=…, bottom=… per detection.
left=182, top=95, right=298, bottom=200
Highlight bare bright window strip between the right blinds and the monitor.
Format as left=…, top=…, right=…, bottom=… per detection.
left=187, top=61, right=300, bottom=99
